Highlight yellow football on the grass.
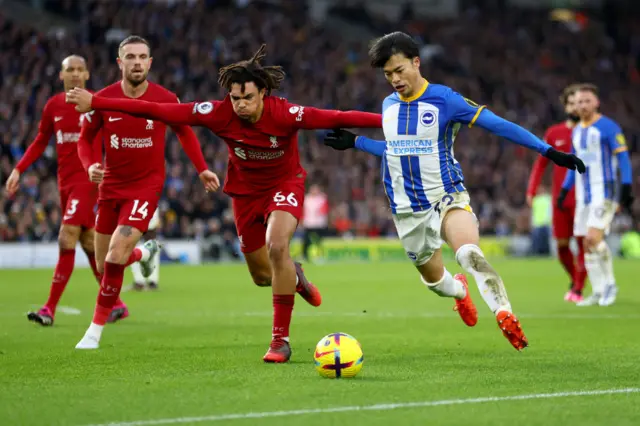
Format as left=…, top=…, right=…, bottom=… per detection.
left=313, top=333, right=364, bottom=379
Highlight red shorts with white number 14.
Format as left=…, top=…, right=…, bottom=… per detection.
left=96, top=197, right=158, bottom=235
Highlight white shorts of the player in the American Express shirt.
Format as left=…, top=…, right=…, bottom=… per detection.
left=393, top=192, right=475, bottom=266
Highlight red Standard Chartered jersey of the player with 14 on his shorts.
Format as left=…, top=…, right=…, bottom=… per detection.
left=82, top=82, right=189, bottom=200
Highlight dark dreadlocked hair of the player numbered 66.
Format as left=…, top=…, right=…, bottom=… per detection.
left=218, top=44, right=285, bottom=95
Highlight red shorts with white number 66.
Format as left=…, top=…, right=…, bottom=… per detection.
left=231, top=180, right=304, bottom=253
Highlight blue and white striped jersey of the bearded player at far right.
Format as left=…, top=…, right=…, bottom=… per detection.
left=572, top=116, right=627, bottom=205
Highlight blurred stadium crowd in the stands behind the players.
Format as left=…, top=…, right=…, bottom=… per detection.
left=0, top=0, right=640, bottom=245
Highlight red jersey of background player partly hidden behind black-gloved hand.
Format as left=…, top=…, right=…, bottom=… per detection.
left=527, top=122, right=575, bottom=206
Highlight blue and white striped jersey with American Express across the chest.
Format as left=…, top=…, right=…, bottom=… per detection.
left=382, top=82, right=484, bottom=213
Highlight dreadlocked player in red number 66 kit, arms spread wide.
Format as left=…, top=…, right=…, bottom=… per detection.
left=67, top=45, right=381, bottom=363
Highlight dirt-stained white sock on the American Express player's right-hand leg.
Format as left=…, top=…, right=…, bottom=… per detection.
left=456, top=244, right=511, bottom=314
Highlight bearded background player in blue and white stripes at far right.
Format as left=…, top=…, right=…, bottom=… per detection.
left=557, top=84, right=633, bottom=306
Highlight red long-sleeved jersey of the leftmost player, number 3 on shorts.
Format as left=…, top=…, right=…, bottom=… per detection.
left=16, top=93, right=102, bottom=189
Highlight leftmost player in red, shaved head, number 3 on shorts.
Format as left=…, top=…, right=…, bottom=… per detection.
left=7, top=55, right=128, bottom=326
